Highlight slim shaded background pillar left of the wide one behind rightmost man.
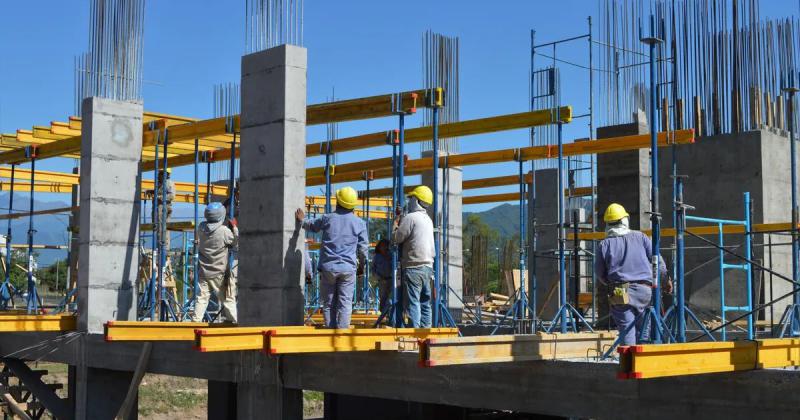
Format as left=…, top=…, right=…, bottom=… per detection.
left=527, top=168, right=559, bottom=321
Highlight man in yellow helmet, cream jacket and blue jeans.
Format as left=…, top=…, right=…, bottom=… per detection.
left=392, top=185, right=435, bottom=328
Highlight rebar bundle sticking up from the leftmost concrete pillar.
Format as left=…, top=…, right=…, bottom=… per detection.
left=85, top=0, right=145, bottom=102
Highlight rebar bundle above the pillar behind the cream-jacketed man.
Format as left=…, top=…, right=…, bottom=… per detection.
left=420, top=30, right=459, bottom=153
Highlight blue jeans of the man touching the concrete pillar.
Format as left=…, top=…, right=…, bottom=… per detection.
left=319, top=271, right=356, bottom=328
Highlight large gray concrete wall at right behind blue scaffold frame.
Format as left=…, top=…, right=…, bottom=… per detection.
left=659, top=130, right=791, bottom=322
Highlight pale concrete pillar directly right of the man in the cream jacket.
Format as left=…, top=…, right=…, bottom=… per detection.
left=422, top=151, right=464, bottom=322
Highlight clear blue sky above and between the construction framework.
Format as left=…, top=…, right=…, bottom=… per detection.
left=0, top=0, right=797, bottom=210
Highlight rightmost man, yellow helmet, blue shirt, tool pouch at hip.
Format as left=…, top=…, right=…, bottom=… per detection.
left=594, top=203, right=672, bottom=345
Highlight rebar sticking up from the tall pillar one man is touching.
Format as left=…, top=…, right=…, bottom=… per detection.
left=245, top=0, right=305, bottom=54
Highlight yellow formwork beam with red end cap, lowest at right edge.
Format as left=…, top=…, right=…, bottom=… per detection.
left=617, top=338, right=800, bottom=379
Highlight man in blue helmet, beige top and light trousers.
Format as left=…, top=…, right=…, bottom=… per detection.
left=193, top=202, right=239, bottom=323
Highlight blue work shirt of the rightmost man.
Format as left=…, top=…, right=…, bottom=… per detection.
left=594, top=230, right=667, bottom=283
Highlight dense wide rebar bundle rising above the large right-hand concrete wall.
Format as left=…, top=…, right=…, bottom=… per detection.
left=599, top=0, right=800, bottom=136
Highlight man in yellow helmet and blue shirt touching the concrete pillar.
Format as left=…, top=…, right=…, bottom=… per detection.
left=295, top=187, right=369, bottom=328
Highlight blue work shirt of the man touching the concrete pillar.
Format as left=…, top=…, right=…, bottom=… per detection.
left=303, top=207, right=369, bottom=273
